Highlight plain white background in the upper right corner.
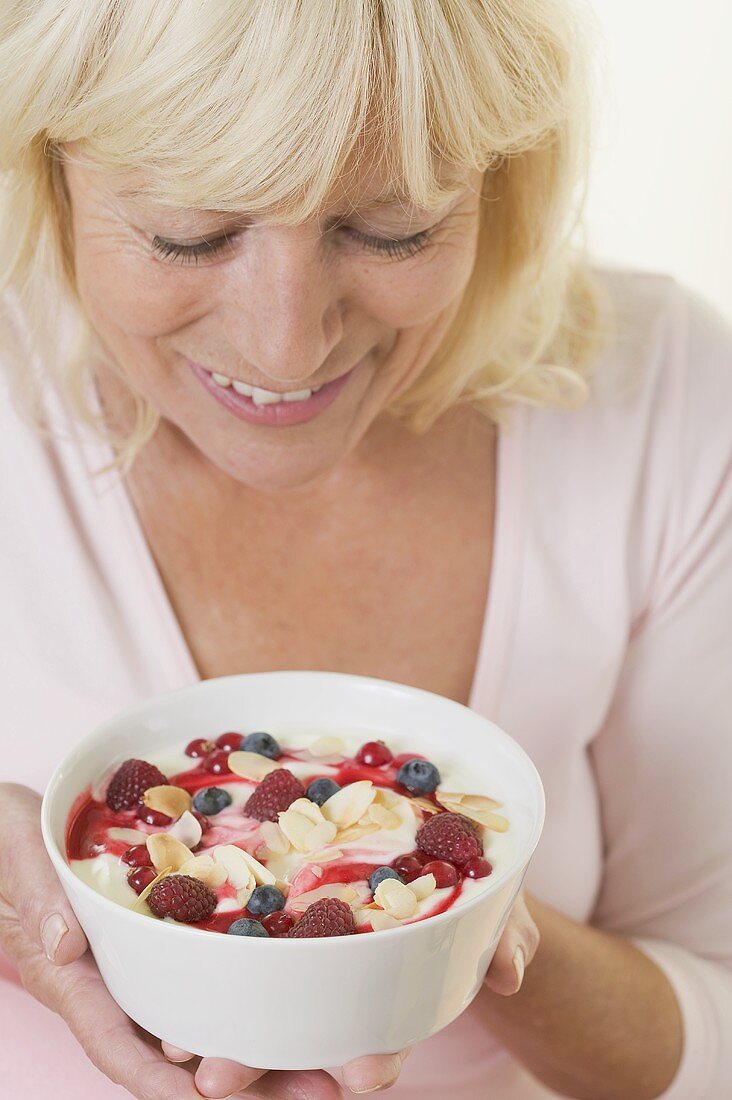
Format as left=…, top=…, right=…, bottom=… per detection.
left=584, top=0, right=732, bottom=321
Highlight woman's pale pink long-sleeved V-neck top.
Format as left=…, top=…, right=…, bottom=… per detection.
left=0, top=268, right=732, bottom=1100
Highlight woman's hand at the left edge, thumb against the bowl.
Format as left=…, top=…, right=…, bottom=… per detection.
left=0, top=783, right=208, bottom=1100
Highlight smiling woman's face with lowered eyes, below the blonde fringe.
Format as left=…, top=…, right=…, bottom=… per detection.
left=64, top=151, right=482, bottom=490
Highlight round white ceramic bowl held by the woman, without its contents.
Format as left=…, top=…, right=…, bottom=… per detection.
left=42, top=672, right=544, bottom=1069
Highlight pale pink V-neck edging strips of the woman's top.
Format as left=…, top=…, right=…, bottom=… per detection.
left=75, top=385, right=526, bottom=717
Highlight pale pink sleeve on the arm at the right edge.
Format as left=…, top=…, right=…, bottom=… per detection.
left=591, top=279, right=732, bottom=1100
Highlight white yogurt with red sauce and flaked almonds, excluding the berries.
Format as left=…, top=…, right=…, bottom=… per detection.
left=66, top=725, right=513, bottom=936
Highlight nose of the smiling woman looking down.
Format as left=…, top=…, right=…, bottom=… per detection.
left=226, top=226, right=342, bottom=389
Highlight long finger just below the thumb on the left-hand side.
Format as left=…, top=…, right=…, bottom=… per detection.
left=57, top=956, right=200, bottom=1100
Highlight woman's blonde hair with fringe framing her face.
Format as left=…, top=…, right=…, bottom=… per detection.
left=0, top=0, right=611, bottom=465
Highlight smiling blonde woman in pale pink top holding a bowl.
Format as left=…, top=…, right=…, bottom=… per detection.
left=0, top=0, right=732, bottom=1100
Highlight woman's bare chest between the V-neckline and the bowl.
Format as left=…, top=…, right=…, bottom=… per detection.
left=129, top=422, right=494, bottom=703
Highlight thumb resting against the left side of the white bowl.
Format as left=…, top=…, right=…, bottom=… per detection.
left=0, top=783, right=88, bottom=966
